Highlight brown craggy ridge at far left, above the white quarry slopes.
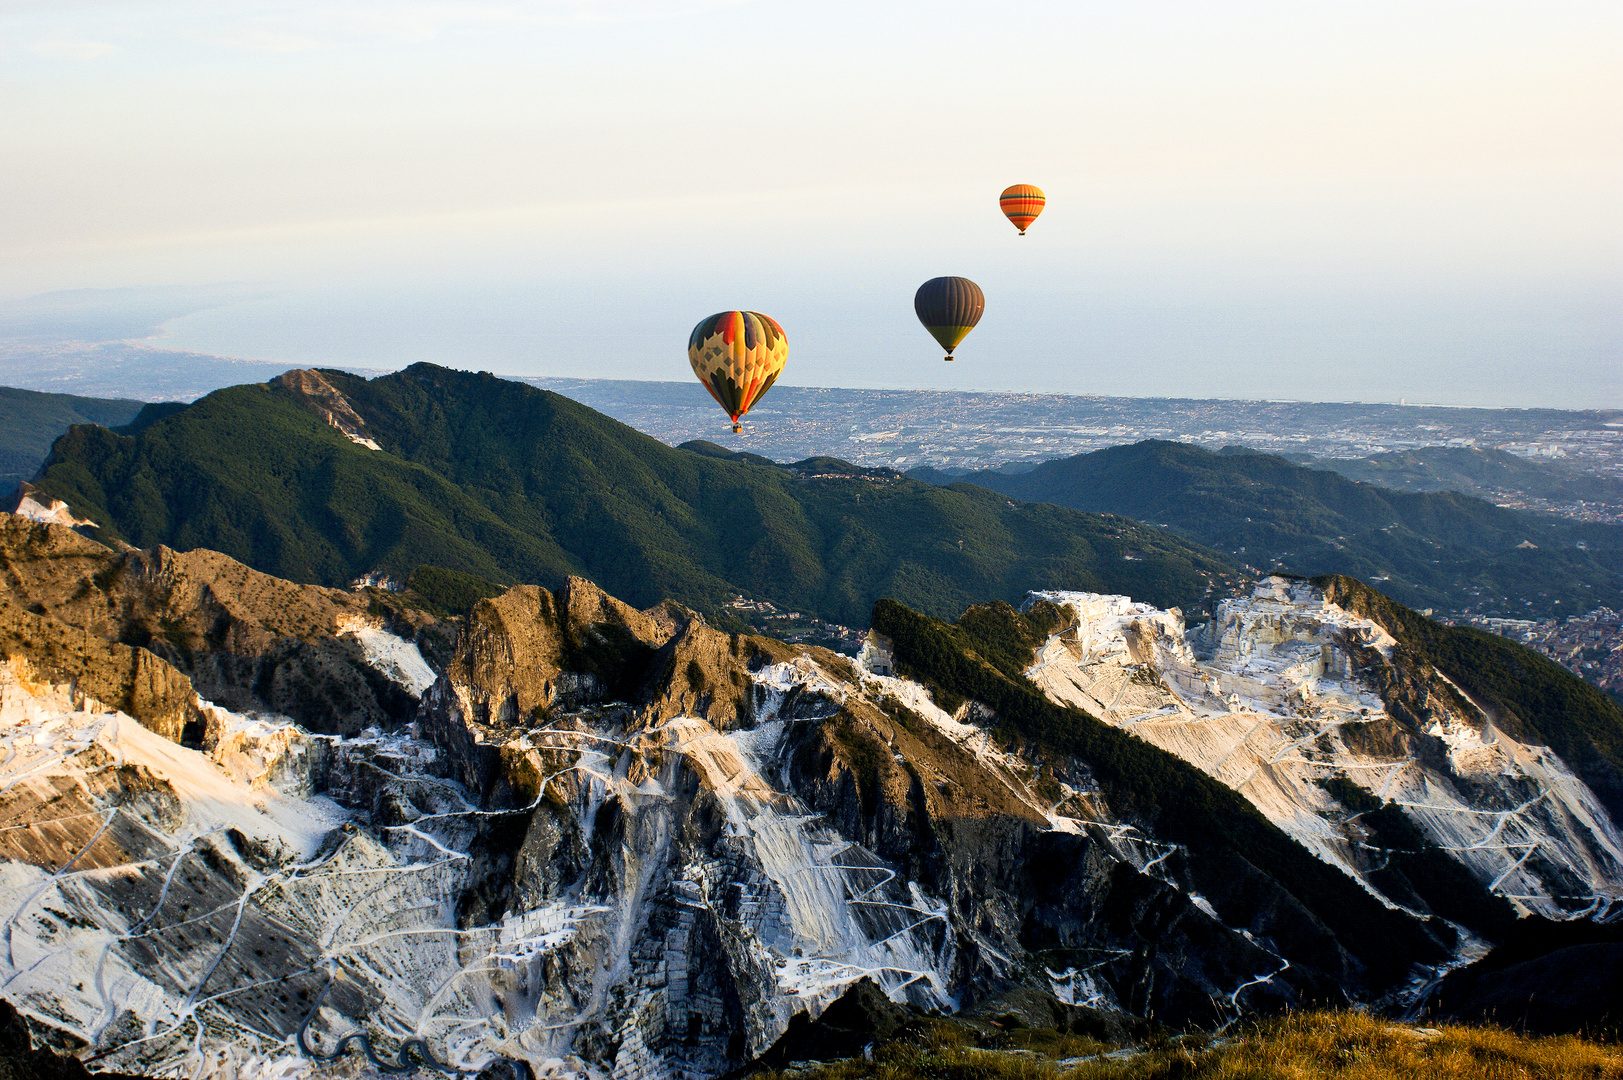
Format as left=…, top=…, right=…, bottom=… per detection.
left=0, top=515, right=454, bottom=734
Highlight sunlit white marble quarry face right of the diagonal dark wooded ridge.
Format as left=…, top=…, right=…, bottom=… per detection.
left=1027, top=578, right=1623, bottom=918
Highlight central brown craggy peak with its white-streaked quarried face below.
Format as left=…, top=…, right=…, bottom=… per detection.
left=405, top=580, right=1355, bottom=1077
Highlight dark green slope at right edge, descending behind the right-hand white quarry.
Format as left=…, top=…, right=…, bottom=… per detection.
left=1313, top=577, right=1623, bottom=815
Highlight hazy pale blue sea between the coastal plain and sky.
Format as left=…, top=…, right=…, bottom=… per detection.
left=153, top=274, right=1623, bottom=409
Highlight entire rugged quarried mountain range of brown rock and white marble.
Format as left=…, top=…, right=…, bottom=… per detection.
left=0, top=516, right=1623, bottom=1078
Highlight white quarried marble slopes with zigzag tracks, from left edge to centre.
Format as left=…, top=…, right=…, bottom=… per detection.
left=0, top=649, right=956, bottom=1077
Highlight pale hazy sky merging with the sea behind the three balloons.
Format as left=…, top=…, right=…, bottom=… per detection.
left=0, top=0, right=1623, bottom=406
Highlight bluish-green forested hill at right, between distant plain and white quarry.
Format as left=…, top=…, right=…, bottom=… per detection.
left=928, top=440, right=1623, bottom=617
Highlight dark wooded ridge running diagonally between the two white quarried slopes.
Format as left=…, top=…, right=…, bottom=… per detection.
left=873, top=599, right=1443, bottom=984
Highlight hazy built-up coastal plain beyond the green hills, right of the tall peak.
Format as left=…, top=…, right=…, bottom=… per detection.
left=535, top=378, right=1623, bottom=521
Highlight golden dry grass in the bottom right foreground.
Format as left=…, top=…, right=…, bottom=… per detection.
left=774, top=1012, right=1623, bottom=1080
